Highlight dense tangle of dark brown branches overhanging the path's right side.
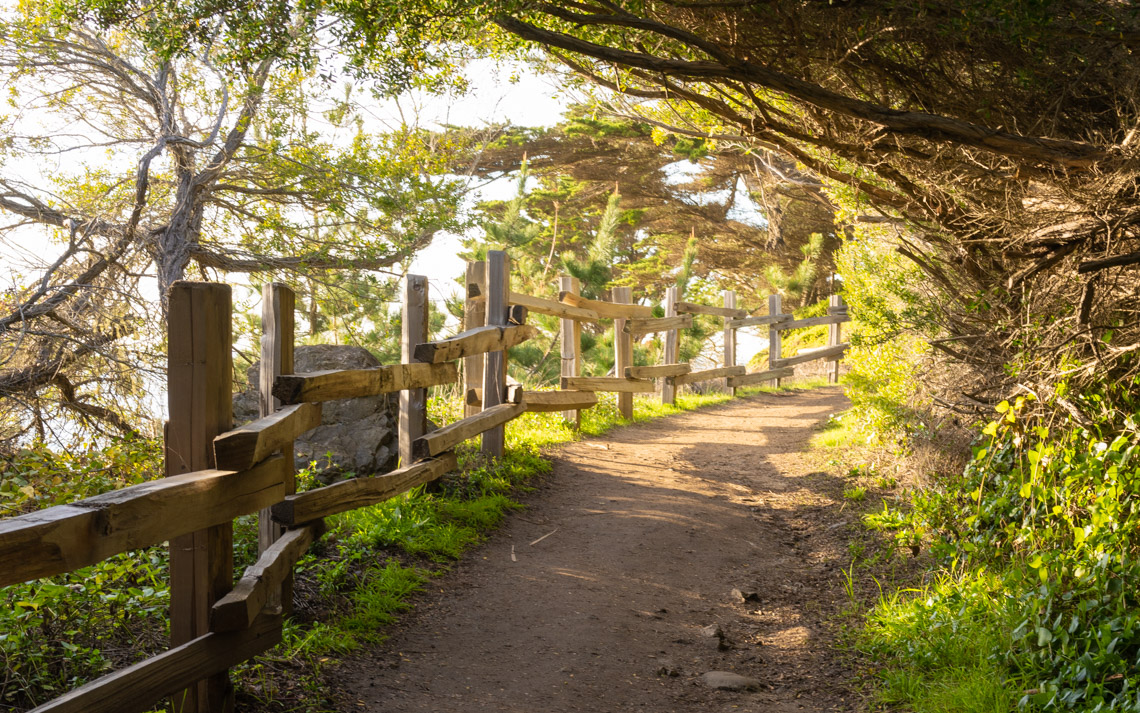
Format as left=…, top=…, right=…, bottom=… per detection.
left=383, top=0, right=1140, bottom=419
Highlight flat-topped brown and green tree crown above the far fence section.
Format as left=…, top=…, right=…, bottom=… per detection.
left=467, top=106, right=838, bottom=308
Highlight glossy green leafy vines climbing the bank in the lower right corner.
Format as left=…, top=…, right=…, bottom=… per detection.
left=857, top=397, right=1140, bottom=712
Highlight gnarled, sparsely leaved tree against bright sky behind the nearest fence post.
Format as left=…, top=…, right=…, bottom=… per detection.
left=0, top=1, right=473, bottom=440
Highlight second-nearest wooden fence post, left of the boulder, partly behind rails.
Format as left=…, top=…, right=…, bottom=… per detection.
left=258, top=282, right=296, bottom=614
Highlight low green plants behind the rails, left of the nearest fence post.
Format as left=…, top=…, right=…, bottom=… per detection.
left=0, top=438, right=169, bottom=707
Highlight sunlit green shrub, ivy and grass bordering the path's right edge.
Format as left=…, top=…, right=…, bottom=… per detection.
left=816, top=330, right=1140, bottom=713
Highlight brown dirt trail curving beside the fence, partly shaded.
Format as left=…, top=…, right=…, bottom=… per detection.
left=332, top=388, right=858, bottom=713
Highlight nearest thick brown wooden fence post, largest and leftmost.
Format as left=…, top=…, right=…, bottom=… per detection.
left=165, top=282, right=234, bottom=713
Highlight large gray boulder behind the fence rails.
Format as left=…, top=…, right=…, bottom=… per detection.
left=234, top=345, right=399, bottom=473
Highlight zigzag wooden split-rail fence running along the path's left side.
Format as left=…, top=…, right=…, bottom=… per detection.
left=0, top=251, right=847, bottom=713
